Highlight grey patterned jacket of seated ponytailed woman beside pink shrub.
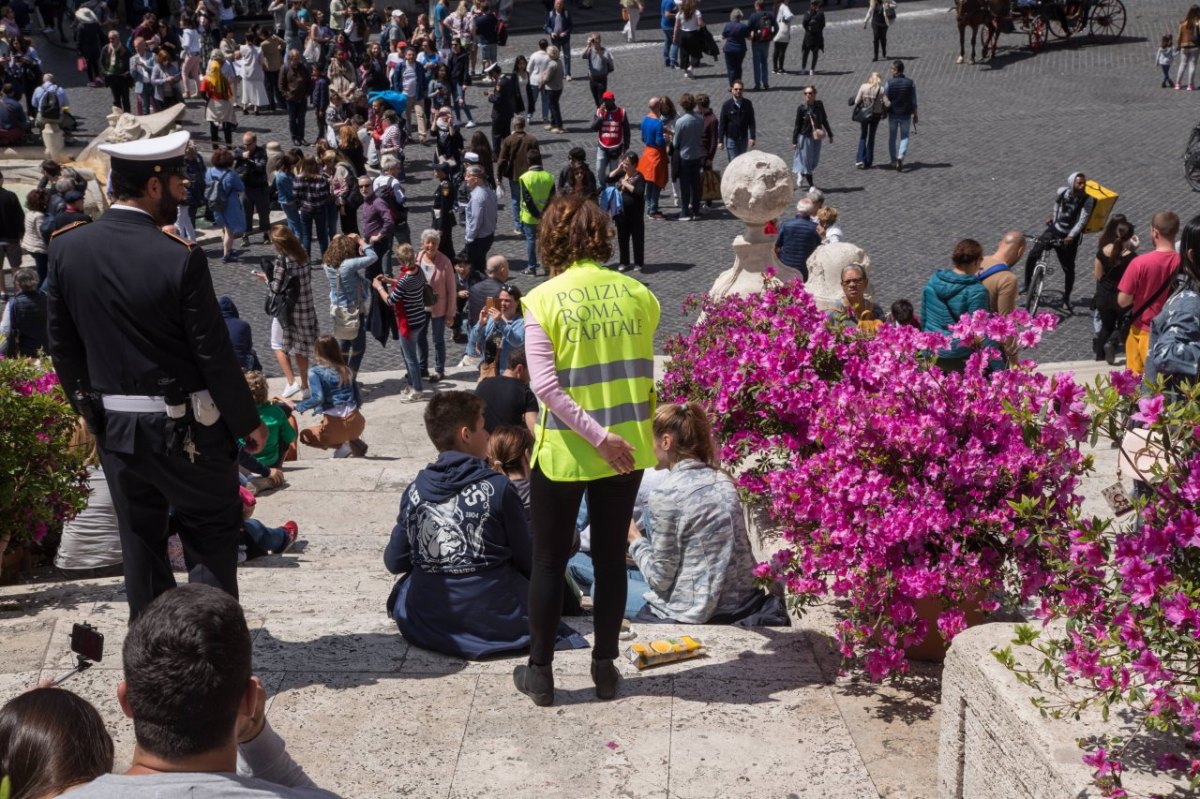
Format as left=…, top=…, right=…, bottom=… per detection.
left=629, top=459, right=757, bottom=624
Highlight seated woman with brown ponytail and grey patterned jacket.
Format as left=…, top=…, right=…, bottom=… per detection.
left=629, top=402, right=763, bottom=624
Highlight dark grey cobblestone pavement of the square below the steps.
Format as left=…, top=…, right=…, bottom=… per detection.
left=35, top=0, right=1200, bottom=370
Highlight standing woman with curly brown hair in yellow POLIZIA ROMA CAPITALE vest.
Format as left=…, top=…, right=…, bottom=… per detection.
left=512, top=194, right=659, bottom=705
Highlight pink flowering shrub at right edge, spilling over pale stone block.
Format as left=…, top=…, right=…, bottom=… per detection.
left=996, top=372, right=1200, bottom=797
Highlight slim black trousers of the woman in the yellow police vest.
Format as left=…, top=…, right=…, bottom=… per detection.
left=529, top=467, right=642, bottom=666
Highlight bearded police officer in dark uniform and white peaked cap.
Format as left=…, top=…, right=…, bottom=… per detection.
left=48, top=131, right=266, bottom=619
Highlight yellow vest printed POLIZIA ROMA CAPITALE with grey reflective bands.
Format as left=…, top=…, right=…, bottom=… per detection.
left=524, top=260, right=660, bottom=482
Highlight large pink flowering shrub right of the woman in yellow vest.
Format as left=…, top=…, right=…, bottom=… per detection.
left=661, top=283, right=1090, bottom=679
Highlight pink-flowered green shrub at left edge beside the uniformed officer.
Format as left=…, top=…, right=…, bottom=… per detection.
left=0, top=359, right=88, bottom=553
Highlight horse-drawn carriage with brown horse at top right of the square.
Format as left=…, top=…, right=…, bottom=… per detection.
left=956, top=0, right=1126, bottom=64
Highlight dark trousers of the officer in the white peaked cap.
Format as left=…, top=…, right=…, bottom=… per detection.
left=100, top=411, right=241, bottom=620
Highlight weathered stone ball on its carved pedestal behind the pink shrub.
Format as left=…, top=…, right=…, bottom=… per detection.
left=709, top=150, right=800, bottom=299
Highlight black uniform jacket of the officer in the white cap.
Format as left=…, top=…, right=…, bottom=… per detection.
left=47, top=208, right=259, bottom=438
